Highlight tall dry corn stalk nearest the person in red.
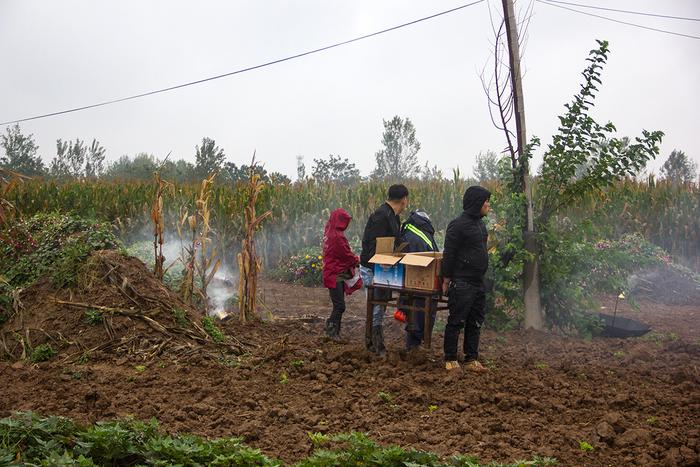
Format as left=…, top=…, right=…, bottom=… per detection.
left=238, top=159, right=272, bottom=323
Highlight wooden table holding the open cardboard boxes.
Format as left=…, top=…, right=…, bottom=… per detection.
left=365, top=284, right=448, bottom=348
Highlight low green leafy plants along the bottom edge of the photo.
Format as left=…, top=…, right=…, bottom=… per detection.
left=0, top=412, right=556, bottom=467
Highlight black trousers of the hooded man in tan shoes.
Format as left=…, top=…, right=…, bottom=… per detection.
left=444, top=281, right=486, bottom=362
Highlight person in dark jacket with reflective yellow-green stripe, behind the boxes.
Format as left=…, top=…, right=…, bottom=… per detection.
left=401, top=211, right=438, bottom=350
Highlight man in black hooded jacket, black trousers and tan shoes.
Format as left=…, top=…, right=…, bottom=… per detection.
left=442, top=186, right=491, bottom=372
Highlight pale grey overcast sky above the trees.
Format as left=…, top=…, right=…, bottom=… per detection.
left=0, top=0, right=700, bottom=178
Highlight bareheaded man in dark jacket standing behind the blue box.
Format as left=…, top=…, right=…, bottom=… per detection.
left=360, top=185, right=408, bottom=355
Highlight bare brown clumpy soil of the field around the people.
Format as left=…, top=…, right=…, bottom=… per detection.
left=0, top=282, right=700, bottom=465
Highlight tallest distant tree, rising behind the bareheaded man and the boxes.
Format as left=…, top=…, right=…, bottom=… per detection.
left=372, top=115, right=420, bottom=180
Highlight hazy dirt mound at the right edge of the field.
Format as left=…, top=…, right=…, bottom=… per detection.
left=630, top=267, right=700, bottom=305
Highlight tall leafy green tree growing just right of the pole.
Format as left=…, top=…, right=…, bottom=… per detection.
left=527, top=41, right=663, bottom=330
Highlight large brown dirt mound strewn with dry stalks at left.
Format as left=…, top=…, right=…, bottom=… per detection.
left=0, top=250, right=242, bottom=361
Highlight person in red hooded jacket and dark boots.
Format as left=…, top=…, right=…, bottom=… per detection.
left=323, top=209, right=362, bottom=341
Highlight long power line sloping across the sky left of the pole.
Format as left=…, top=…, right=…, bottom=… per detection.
left=0, top=0, right=484, bottom=125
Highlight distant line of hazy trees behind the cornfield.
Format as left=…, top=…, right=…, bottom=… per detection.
left=0, top=119, right=698, bottom=185
